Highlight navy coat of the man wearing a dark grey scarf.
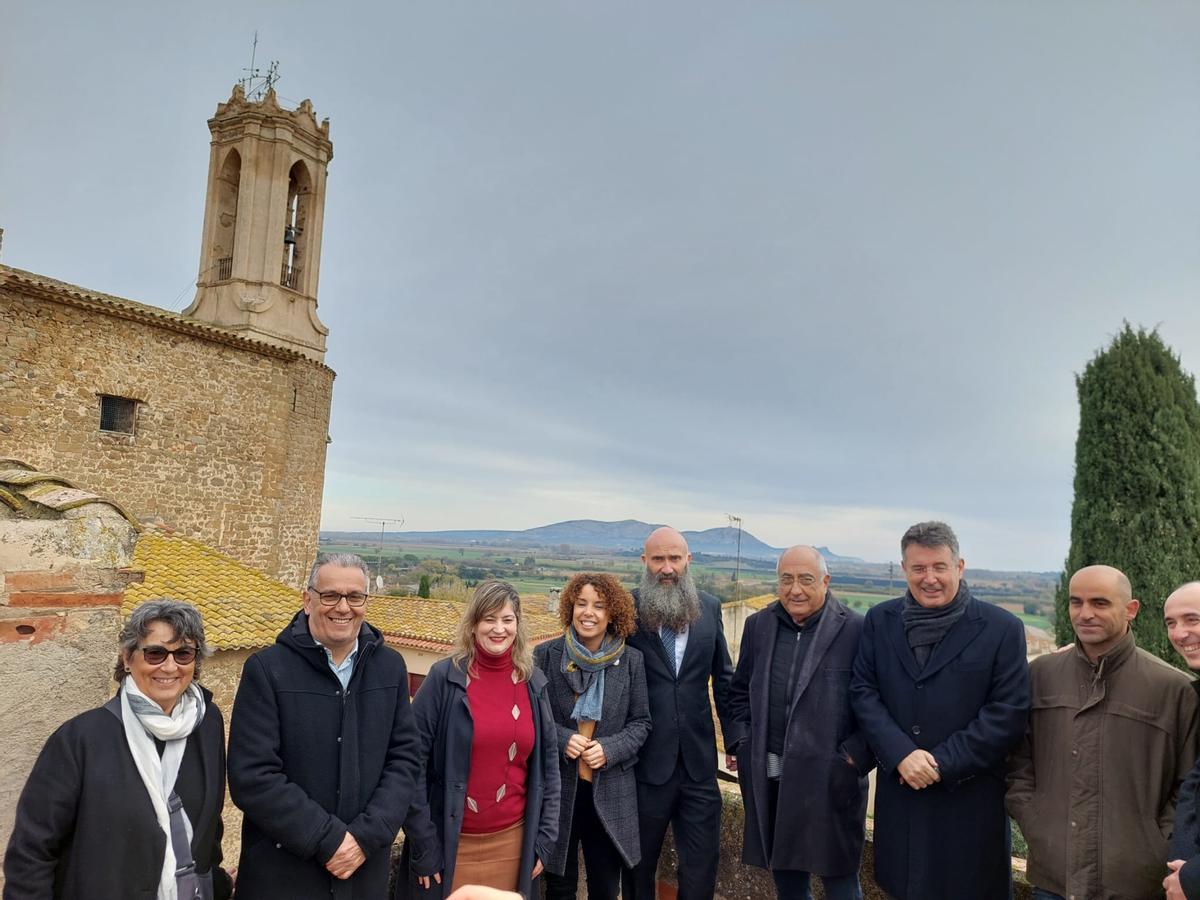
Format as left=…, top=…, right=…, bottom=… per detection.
left=851, top=584, right=1030, bottom=900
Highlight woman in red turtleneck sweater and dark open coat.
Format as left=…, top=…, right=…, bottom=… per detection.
left=397, top=581, right=559, bottom=898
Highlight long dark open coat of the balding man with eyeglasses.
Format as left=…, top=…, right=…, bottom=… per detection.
left=732, top=594, right=875, bottom=876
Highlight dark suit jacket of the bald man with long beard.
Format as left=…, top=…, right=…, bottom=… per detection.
left=626, top=590, right=740, bottom=785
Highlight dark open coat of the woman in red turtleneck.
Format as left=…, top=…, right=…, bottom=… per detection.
left=396, top=659, right=562, bottom=900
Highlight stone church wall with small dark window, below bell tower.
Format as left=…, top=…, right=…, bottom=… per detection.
left=0, top=285, right=334, bottom=586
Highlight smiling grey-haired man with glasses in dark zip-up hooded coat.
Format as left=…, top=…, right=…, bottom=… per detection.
left=229, top=553, right=419, bottom=900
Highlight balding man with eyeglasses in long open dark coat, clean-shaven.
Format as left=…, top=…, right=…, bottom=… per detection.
left=730, top=545, right=875, bottom=900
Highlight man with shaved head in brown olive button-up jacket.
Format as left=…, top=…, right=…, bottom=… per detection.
left=1006, top=565, right=1198, bottom=900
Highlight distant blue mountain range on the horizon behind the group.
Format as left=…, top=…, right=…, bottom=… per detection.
left=320, top=518, right=863, bottom=563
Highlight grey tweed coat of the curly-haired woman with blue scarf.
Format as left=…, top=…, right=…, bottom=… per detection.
left=534, top=637, right=650, bottom=871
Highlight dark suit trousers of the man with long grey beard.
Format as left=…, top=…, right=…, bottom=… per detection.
left=622, top=766, right=721, bottom=900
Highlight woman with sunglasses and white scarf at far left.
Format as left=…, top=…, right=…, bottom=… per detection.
left=4, top=600, right=233, bottom=900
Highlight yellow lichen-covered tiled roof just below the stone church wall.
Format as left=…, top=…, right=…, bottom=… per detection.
left=121, top=529, right=301, bottom=650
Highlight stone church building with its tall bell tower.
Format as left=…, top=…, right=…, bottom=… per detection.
left=0, top=86, right=334, bottom=586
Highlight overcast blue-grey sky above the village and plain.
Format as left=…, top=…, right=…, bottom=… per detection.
left=0, top=0, right=1200, bottom=570
